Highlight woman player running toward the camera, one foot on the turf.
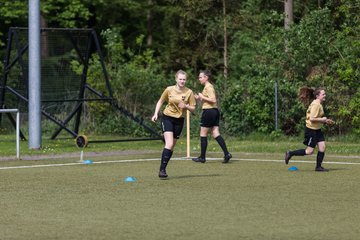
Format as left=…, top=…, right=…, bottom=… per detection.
left=151, top=70, right=196, bottom=179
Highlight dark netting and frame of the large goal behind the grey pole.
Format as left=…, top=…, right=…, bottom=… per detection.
left=0, top=28, right=159, bottom=139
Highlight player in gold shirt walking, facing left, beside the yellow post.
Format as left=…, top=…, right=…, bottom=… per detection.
left=192, top=70, right=232, bottom=163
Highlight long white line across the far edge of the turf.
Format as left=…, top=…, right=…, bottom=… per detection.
left=0, top=157, right=360, bottom=170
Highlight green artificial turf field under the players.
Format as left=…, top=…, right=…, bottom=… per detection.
left=0, top=153, right=360, bottom=240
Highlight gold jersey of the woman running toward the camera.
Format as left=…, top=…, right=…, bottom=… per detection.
left=160, top=85, right=196, bottom=118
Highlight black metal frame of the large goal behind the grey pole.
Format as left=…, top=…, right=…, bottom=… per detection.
left=0, top=28, right=163, bottom=143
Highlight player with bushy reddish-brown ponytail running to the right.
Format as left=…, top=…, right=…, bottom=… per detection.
left=285, top=87, right=334, bottom=172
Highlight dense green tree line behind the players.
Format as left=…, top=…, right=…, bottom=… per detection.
left=0, top=0, right=360, bottom=135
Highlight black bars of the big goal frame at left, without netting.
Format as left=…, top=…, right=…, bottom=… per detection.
left=0, top=27, right=162, bottom=143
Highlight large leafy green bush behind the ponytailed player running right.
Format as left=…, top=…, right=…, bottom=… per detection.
left=222, top=8, right=360, bottom=137
